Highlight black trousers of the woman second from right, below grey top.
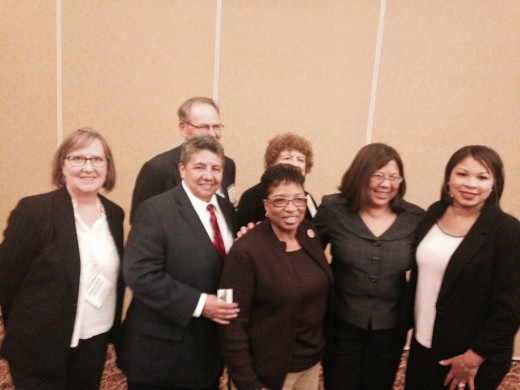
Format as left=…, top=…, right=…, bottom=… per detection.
left=323, top=319, right=406, bottom=390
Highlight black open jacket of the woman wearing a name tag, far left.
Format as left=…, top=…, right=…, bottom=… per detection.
left=0, top=189, right=124, bottom=377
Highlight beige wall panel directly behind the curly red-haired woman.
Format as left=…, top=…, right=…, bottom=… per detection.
left=220, top=0, right=379, bottom=200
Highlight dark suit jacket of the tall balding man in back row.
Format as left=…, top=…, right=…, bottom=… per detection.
left=130, top=146, right=236, bottom=223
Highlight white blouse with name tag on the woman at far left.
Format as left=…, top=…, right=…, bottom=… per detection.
left=70, top=200, right=120, bottom=347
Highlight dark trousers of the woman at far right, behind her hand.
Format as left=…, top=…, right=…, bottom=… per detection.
left=404, top=337, right=511, bottom=390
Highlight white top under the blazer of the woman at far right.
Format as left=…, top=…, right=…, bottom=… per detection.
left=414, top=224, right=464, bottom=348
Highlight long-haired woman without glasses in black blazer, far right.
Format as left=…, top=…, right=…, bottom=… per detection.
left=406, top=146, right=520, bottom=390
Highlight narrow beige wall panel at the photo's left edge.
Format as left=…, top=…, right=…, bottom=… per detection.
left=0, top=0, right=56, bottom=227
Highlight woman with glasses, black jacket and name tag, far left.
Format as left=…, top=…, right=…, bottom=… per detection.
left=0, top=128, right=124, bottom=390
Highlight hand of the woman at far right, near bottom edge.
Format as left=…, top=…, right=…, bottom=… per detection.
left=439, top=349, right=484, bottom=390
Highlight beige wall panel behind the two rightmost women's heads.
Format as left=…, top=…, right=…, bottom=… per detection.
left=374, top=0, right=520, bottom=216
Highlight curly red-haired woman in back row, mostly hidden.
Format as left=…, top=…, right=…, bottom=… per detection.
left=237, top=133, right=317, bottom=226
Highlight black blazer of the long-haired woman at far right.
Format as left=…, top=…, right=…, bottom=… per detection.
left=411, top=202, right=520, bottom=375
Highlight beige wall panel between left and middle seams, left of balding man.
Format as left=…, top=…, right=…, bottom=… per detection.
left=63, top=0, right=215, bottom=219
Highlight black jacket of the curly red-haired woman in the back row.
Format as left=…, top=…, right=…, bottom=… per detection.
left=237, top=183, right=318, bottom=227
